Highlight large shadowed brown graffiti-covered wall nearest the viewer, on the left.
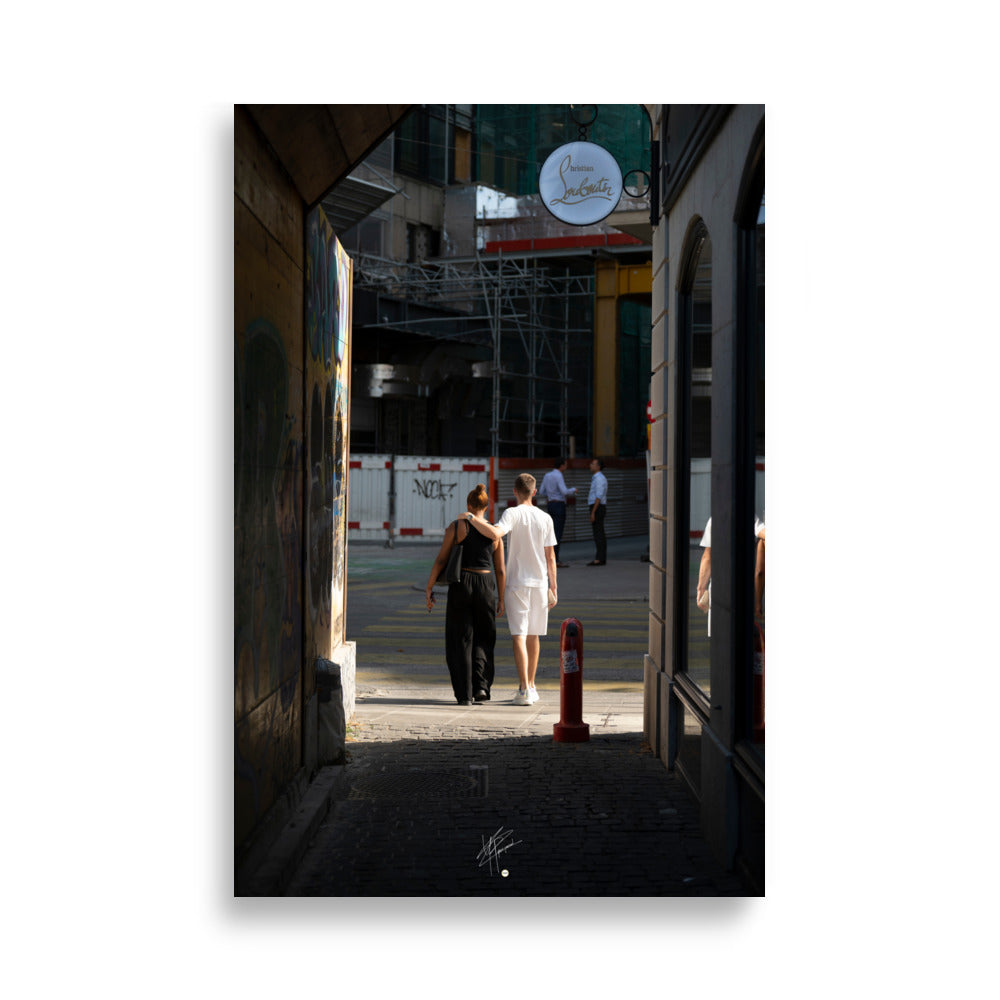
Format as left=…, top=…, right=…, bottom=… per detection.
left=233, top=112, right=306, bottom=860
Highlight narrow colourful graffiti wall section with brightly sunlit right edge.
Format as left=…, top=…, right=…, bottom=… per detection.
left=306, top=208, right=351, bottom=656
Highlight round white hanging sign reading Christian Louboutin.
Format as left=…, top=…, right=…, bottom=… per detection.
left=538, top=142, right=622, bottom=226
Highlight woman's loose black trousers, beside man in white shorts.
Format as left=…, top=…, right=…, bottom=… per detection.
left=444, top=572, right=497, bottom=701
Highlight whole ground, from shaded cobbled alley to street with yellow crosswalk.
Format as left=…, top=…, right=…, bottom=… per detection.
left=279, top=538, right=754, bottom=897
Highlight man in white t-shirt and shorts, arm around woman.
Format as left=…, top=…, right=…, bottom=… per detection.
left=462, top=473, right=558, bottom=705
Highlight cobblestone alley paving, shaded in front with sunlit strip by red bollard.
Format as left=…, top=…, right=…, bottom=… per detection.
left=285, top=696, right=752, bottom=896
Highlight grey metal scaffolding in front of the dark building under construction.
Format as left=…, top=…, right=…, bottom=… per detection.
left=354, top=252, right=594, bottom=458
